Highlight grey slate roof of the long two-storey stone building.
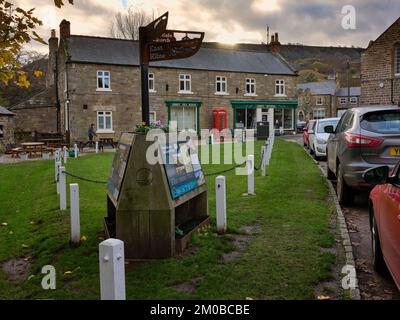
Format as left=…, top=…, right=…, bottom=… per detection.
left=67, top=36, right=296, bottom=75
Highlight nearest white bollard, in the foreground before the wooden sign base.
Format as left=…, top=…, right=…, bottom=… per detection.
left=99, top=239, right=126, bottom=300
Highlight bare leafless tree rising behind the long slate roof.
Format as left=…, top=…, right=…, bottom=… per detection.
left=110, top=7, right=154, bottom=40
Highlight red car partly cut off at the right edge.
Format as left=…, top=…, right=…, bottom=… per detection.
left=364, top=163, right=400, bottom=290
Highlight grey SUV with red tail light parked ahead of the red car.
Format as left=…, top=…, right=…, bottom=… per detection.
left=325, top=106, right=400, bottom=205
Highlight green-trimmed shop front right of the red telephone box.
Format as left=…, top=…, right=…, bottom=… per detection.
left=231, top=100, right=298, bottom=132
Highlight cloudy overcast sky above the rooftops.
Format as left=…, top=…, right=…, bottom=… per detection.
left=12, top=0, right=400, bottom=50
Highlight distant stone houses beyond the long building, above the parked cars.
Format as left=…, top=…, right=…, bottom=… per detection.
left=297, top=81, right=360, bottom=121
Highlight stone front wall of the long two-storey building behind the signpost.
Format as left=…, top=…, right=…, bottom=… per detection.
left=65, top=63, right=297, bottom=143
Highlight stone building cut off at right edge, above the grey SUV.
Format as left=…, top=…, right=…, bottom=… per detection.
left=361, top=18, right=400, bottom=105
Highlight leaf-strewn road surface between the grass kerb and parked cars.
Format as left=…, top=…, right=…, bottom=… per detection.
left=283, top=135, right=400, bottom=300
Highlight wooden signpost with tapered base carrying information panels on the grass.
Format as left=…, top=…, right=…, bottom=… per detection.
left=104, top=13, right=206, bottom=260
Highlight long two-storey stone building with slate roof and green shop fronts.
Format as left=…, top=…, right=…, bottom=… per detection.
left=14, top=20, right=297, bottom=143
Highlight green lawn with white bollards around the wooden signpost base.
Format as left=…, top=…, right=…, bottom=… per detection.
left=0, top=140, right=335, bottom=299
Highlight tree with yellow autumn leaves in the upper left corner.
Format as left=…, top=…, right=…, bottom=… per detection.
left=0, top=0, right=73, bottom=88
